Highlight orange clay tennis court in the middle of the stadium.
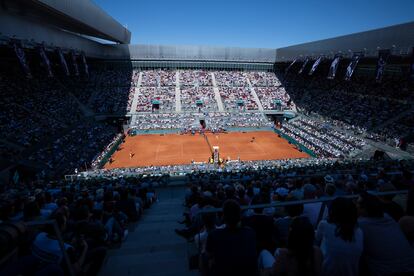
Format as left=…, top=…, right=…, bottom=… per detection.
left=105, top=131, right=309, bottom=169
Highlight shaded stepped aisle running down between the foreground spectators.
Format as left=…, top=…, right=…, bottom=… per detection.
left=101, top=187, right=198, bottom=276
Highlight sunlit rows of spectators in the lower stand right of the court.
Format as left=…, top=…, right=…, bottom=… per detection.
left=281, top=117, right=365, bottom=158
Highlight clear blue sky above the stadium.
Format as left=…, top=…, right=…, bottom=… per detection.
left=93, top=0, right=414, bottom=48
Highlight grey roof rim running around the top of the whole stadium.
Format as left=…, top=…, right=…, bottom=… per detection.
left=0, top=0, right=414, bottom=64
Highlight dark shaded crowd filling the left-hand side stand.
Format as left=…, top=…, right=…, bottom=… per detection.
left=0, top=59, right=130, bottom=178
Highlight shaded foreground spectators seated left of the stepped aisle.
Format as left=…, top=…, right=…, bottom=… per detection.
left=0, top=178, right=158, bottom=275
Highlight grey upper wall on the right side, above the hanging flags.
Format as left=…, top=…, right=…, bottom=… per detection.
left=276, top=22, right=414, bottom=61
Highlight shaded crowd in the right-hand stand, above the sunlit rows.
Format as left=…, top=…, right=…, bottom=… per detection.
left=283, top=71, right=414, bottom=149
